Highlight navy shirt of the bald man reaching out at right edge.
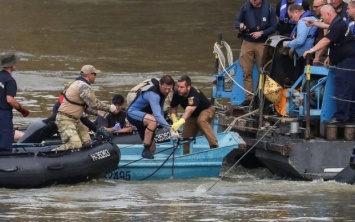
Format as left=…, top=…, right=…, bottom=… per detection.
left=324, top=16, right=355, bottom=65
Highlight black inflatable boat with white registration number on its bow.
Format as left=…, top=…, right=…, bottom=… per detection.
left=0, top=140, right=121, bottom=188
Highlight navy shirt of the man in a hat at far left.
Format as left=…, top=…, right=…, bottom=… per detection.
left=0, top=70, right=17, bottom=110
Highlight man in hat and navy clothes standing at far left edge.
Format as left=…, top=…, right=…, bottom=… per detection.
left=0, top=53, right=30, bottom=153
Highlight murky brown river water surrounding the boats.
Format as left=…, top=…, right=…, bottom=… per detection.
left=0, top=0, right=355, bottom=221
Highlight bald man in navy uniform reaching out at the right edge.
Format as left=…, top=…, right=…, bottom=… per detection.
left=303, top=5, right=355, bottom=124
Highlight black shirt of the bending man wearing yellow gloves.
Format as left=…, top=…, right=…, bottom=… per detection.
left=170, top=87, right=212, bottom=116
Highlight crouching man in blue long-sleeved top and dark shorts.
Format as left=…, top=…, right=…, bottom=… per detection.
left=128, top=75, right=174, bottom=159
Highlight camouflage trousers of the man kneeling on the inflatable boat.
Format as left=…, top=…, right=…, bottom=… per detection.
left=53, top=113, right=91, bottom=151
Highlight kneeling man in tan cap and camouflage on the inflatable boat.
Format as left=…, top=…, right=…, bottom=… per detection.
left=52, top=65, right=117, bottom=151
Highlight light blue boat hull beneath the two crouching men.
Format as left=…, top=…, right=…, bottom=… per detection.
left=106, top=132, right=244, bottom=180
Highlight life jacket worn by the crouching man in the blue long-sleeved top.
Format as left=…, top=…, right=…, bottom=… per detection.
left=130, top=78, right=166, bottom=113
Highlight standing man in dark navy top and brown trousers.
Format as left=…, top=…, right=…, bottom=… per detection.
left=234, top=0, right=277, bottom=106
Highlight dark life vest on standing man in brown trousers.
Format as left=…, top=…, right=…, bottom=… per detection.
left=242, top=0, right=271, bottom=32
